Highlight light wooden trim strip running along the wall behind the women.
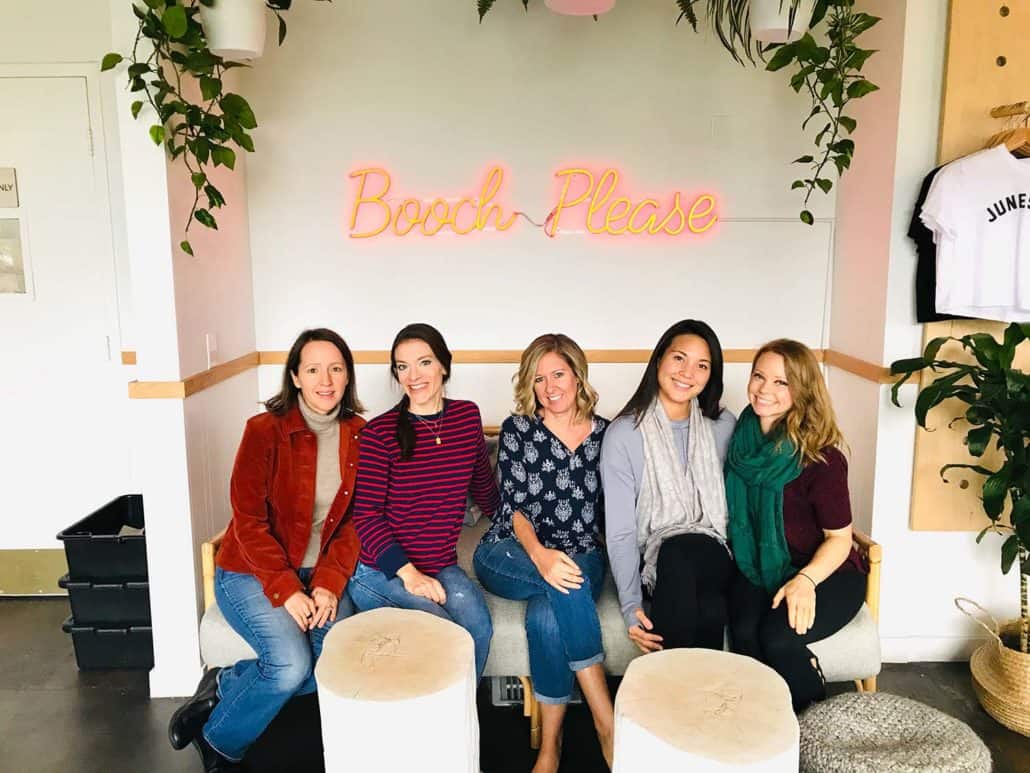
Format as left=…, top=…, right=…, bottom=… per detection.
left=122, top=349, right=893, bottom=400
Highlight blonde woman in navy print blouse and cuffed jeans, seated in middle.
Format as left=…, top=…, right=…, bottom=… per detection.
left=474, top=334, right=614, bottom=773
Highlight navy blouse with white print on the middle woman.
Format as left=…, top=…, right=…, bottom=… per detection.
left=483, top=415, right=609, bottom=554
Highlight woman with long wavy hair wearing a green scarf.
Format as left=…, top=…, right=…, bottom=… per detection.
left=726, top=339, right=866, bottom=711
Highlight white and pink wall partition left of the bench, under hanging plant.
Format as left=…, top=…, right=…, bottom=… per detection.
left=101, top=0, right=256, bottom=697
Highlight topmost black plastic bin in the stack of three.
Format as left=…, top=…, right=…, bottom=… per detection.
left=58, top=494, right=147, bottom=582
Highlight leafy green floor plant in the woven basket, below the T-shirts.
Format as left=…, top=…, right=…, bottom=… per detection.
left=891, top=323, right=1030, bottom=653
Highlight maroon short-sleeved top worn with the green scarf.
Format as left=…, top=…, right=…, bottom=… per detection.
left=783, top=447, right=868, bottom=573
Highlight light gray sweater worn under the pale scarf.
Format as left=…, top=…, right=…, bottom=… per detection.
left=600, top=408, right=736, bottom=628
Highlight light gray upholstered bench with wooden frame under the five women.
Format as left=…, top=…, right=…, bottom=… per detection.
left=200, top=518, right=882, bottom=748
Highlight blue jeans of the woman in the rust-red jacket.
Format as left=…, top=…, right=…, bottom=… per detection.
left=203, top=567, right=354, bottom=762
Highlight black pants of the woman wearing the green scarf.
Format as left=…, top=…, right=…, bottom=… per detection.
left=729, top=569, right=866, bottom=711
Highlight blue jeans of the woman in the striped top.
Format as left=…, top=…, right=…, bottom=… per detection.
left=347, top=562, right=493, bottom=680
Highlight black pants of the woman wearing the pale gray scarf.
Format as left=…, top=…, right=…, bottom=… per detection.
left=651, top=534, right=735, bottom=649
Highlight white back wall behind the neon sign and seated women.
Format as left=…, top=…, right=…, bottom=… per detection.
left=243, top=0, right=833, bottom=385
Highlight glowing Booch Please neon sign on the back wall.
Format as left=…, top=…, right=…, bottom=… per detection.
left=349, top=166, right=719, bottom=239
